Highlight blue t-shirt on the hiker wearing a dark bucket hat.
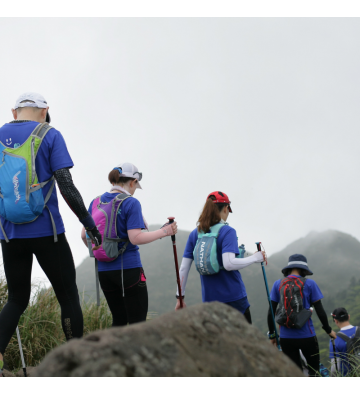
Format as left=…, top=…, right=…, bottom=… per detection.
left=270, top=274, right=324, bottom=339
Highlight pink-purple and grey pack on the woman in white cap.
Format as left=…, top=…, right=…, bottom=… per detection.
left=91, top=193, right=131, bottom=262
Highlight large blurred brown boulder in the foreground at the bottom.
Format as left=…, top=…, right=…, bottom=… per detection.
left=35, top=302, right=303, bottom=377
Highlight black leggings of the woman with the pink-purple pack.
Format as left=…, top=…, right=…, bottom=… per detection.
left=99, top=267, right=148, bottom=326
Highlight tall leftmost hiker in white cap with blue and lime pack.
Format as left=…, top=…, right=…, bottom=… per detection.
left=0, top=92, right=101, bottom=374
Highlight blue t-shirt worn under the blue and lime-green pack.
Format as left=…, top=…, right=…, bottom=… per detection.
left=0, top=122, right=74, bottom=240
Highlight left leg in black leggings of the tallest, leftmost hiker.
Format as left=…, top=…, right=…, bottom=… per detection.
left=0, top=239, right=33, bottom=355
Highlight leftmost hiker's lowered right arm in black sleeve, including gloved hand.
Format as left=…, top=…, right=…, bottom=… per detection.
left=54, top=168, right=102, bottom=245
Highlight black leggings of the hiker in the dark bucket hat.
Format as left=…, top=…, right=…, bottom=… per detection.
left=280, top=336, right=320, bottom=376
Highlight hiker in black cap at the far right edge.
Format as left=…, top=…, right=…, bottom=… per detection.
left=330, top=307, right=360, bottom=376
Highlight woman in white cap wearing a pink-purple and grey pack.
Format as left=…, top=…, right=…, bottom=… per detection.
left=81, top=163, right=177, bottom=326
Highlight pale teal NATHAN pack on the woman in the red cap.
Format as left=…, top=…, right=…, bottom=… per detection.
left=193, top=224, right=245, bottom=276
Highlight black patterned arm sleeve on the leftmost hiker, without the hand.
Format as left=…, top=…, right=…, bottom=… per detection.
left=54, top=168, right=90, bottom=222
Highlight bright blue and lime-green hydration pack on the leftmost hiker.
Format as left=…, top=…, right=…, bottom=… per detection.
left=0, top=123, right=57, bottom=242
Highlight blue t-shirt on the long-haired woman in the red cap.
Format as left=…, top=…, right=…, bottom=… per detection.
left=183, top=225, right=246, bottom=303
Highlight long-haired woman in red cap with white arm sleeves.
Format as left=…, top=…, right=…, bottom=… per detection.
left=175, top=191, right=265, bottom=324
